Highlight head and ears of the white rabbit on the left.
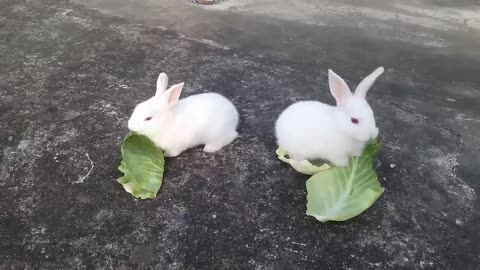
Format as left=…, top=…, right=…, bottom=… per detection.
left=128, top=73, right=183, bottom=136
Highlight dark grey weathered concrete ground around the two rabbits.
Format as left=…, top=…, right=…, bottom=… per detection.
left=0, top=0, right=480, bottom=269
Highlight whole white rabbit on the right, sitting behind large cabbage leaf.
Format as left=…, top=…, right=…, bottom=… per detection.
left=275, top=67, right=384, bottom=166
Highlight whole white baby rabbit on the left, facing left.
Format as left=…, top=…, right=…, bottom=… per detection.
left=128, top=73, right=239, bottom=157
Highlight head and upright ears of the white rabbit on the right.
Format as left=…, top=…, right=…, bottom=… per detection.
left=328, top=67, right=384, bottom=142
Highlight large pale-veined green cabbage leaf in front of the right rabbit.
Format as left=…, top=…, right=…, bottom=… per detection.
left=307, top=141, right=384, bottom=222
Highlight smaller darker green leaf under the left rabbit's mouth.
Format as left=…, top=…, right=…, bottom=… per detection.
left=117, top=133, right=165, bottom=199
